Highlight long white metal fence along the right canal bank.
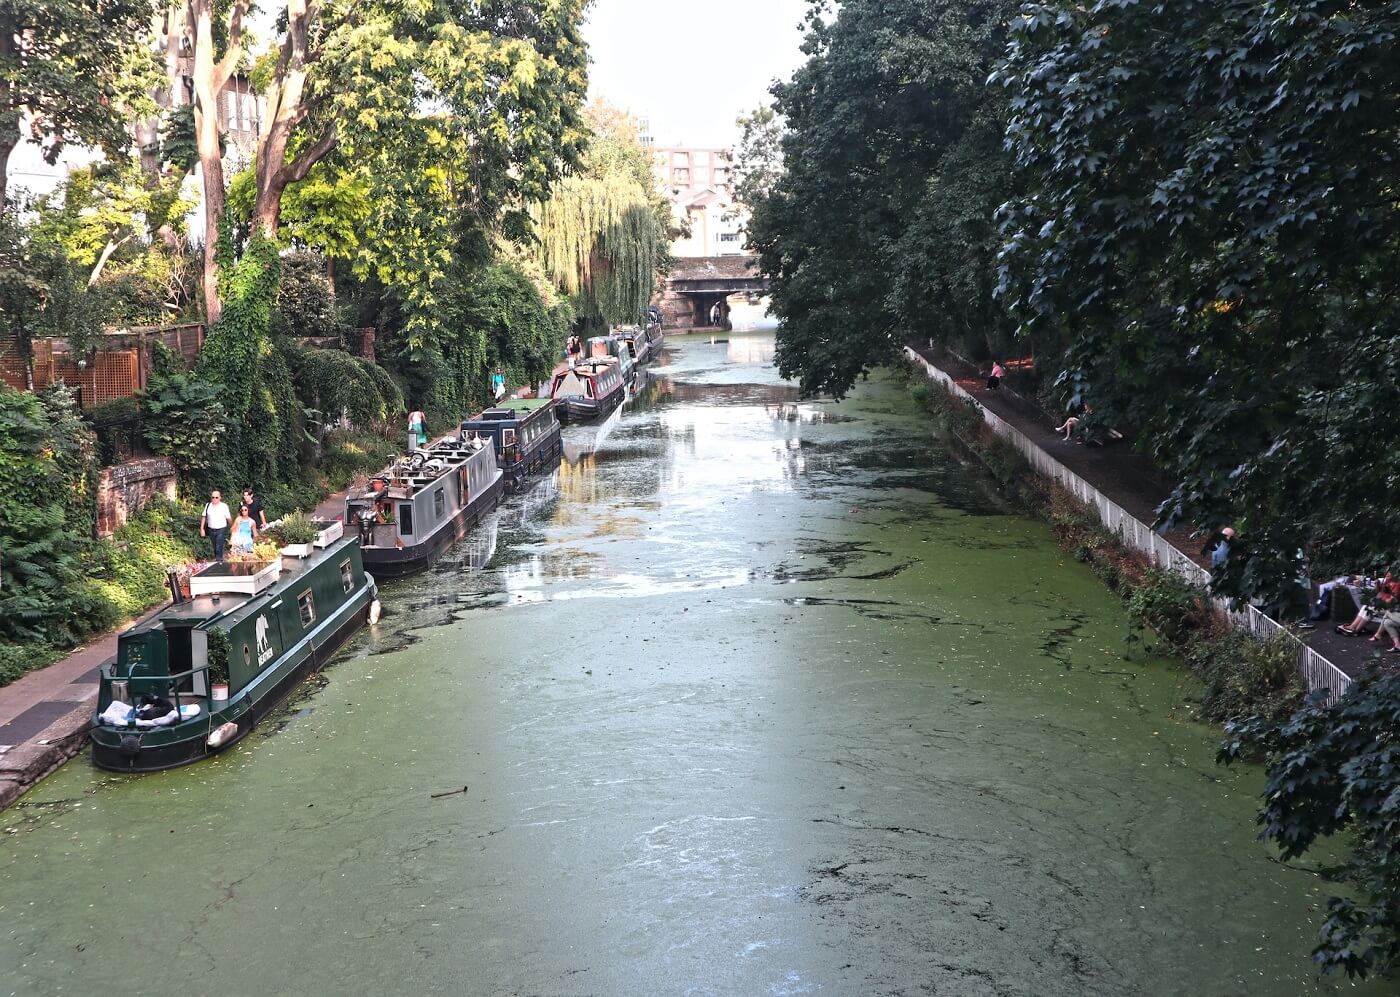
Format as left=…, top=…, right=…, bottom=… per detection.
left=904, top=347, right=1351, bottom=699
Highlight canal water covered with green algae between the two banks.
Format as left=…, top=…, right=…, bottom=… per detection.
left=0, top=333, right=1390, bottom=997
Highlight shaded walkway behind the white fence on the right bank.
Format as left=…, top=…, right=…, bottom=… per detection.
left=910, top=343, right=1377, bottom=676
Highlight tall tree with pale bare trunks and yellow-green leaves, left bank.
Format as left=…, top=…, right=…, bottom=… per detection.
left=179, top=0, right=587, bottom=323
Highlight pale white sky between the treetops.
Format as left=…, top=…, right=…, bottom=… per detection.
left=584, top=0, right=808, bottom=148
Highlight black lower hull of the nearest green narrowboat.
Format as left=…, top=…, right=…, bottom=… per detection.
left=91, top=585, right=374, bottom=773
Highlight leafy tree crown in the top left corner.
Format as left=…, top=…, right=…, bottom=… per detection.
left=0, top=0, right=151, bottom=213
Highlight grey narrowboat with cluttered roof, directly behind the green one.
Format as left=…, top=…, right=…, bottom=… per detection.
left=346, top=437, right=505, bottom=581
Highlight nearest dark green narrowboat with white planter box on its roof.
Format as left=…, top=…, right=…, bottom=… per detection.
left=90, top=536, right=377, bottom=772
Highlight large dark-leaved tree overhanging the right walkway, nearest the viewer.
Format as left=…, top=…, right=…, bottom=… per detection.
left=994, top=0, right=1400, bottom=609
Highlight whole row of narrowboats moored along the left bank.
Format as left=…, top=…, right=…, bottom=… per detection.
left=91, top=319, right=661, bottom=772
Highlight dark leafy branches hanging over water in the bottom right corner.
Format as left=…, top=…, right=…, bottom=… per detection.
left=1221, top=669, right=1400, bottom=976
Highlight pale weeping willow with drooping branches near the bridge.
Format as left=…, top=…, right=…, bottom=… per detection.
left=535, top=106, right=671, bottom=329
